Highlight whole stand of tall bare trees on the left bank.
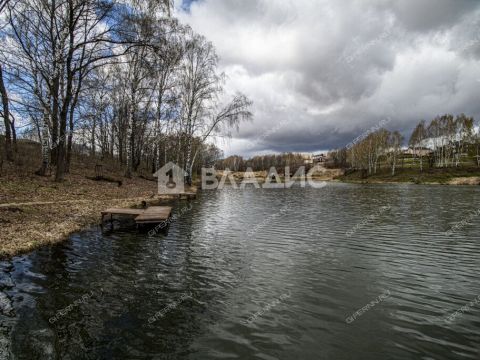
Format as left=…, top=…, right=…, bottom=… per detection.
left=0, top=0, right=252, bottom=182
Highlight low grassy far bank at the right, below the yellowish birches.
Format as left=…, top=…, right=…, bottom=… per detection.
left=337, top=167, right=480, bottom=185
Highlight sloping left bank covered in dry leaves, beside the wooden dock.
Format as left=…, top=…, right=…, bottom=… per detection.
left=0, top=142, right=186, bottom=258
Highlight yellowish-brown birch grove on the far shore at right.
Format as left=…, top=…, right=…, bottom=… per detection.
left=329, top=114, right=480, bottom=175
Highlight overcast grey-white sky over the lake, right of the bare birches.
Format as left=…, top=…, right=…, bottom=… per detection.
left=177, top=0, right=480, bottom=156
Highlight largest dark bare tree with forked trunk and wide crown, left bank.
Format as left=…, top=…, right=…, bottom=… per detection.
left=4, top=0, right=172, bottom=181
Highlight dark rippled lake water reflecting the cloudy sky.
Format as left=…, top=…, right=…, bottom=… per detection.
left=0, top=183, right=480, bottom=360
